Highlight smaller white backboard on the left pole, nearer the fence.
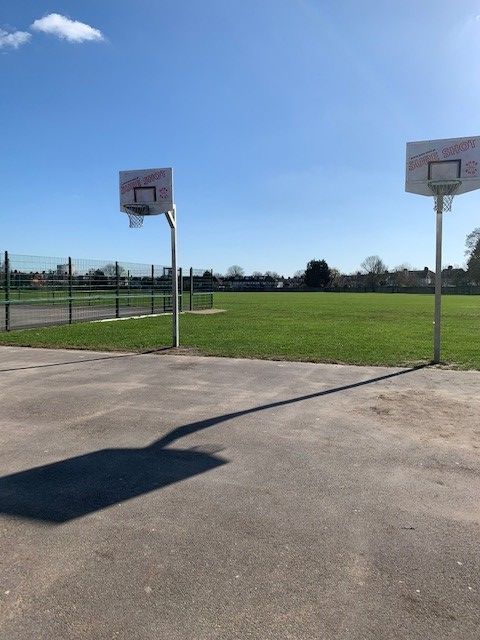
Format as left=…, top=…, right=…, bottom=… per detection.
left=120, top=168, right=173, bottom=214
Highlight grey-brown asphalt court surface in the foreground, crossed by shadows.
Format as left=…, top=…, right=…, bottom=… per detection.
left=0, top=347, right=480, bottom=640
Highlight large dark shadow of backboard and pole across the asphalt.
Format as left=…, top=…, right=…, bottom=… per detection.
left=0, top=365, right=428, bottom=523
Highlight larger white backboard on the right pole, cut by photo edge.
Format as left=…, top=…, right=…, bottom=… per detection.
left=405, top=136, right=480, bottom=196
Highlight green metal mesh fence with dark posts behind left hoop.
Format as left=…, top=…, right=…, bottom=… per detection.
left=0, top=251, right=213, bottom=331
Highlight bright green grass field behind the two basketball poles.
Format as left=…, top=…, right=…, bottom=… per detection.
left=0, top=293, right=480, bottom=369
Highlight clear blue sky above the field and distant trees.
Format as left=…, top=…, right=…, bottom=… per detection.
left=0, top=0, right=480, bottom=275
